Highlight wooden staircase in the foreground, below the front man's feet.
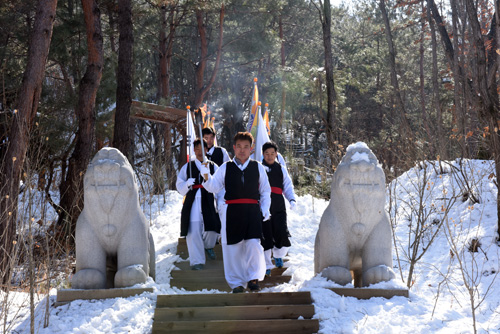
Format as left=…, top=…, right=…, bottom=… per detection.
left=153, top=292, right=319, bottom=334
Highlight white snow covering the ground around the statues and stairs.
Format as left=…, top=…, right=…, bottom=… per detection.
left=5, top=160, right=500, bottom=333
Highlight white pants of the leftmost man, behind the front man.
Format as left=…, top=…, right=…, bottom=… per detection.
left=186, top=220, right=219, bottom=266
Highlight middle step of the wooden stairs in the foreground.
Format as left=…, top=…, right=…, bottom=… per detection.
left=154, top=304, right=314, bottom=322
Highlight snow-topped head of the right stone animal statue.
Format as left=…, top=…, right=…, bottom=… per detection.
left=331, top=144, right=385, bottom=212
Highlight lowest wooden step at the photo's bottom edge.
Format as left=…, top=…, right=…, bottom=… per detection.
left=153, top=319, right=319, bottom=334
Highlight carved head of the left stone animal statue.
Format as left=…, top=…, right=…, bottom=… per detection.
left=84, top=148, right=137, bottom=214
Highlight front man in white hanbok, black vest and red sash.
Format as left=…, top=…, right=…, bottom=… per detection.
left=201, top=132, right=271, bottom=293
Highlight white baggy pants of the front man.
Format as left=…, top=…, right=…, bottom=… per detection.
left=222, top=239, right=266, bottom=289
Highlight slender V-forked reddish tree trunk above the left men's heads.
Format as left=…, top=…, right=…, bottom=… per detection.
left=194, top=4, right=225, bottom=108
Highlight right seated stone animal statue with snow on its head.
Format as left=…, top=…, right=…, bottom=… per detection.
left=314, top=142, right=395, bottom=287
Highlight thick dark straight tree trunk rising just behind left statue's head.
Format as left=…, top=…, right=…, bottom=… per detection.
left=113, top=0, right=134, bottom=158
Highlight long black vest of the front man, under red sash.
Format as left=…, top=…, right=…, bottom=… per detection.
left=224, top=160, right=262, bottom=245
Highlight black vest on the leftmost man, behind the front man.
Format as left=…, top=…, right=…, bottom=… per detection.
left=181, top=161, right=221, bottom=237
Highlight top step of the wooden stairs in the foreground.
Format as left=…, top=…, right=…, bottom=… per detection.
left=156, top=291, right=312, bottom=308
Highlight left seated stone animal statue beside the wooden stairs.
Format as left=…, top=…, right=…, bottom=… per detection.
left=71, top=148, right=155, bottom=289
